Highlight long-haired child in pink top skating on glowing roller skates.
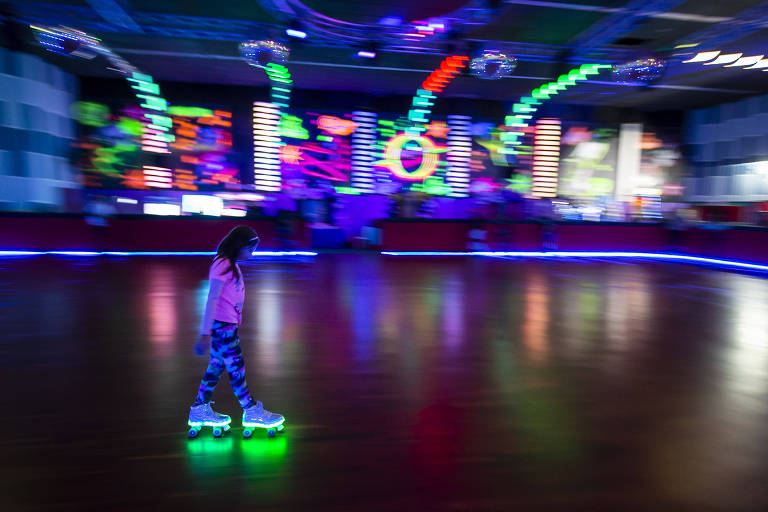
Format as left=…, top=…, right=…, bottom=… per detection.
left=188, top=226, right=284, bottom=437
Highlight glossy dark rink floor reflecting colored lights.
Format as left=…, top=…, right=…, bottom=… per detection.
left=0, top=255, right=768, bottom=511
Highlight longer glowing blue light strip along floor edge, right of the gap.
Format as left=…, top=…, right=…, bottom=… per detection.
left=381, top=251, right=768, bottom=271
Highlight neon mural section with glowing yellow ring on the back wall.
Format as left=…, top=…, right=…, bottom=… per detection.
left=253, top=106, right=516, bottom=198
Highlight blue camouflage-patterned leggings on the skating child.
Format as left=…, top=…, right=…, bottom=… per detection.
left=195, top=320, right=251, bottom=408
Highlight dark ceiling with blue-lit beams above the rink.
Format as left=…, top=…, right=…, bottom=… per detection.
left=5, top=0, right=768, bottom=111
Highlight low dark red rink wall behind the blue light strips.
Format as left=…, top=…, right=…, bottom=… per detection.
left=0, top=213, right=768, bottom=263
